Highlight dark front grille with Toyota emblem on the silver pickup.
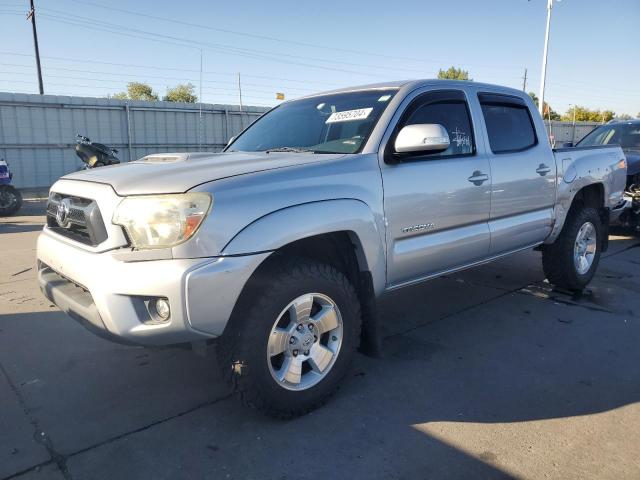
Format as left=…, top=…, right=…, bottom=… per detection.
left=47, top=193, right=107, bottom=247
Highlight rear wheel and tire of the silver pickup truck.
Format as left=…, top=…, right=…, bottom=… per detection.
left=542, top=207, right=603, bottom=291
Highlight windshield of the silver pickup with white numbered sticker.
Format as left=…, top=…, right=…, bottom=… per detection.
left=225, top=89, right=397, bottom=153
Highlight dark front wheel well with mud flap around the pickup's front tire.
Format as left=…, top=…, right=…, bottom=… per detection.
left=234, top=231, right=380, bottom=356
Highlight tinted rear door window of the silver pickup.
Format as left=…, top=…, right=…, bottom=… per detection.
left=481, top=102, right=537, bottom=153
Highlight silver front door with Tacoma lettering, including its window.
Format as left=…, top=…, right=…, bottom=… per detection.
left=380, top=90, right=491, bottom=288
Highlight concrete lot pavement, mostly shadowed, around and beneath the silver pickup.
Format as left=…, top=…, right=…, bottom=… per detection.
left=0, top=202, right=640, bottom=480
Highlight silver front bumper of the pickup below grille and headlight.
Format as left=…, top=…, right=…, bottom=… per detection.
left=37, top=228, right=269, bottom=345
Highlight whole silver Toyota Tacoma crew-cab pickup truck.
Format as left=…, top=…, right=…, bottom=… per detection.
left=37, top=80, right=626, bottom=418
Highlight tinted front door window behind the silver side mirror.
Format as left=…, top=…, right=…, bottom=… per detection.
left=403, top=100, right=474, bottom=156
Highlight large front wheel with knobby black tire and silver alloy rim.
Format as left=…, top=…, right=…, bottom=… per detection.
left=217, top=258, right=361, bottom=418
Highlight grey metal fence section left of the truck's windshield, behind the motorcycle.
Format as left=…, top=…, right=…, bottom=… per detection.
left=0, top=92, right=268, bottom=190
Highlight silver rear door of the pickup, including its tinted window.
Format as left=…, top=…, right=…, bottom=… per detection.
left=478, top=93, right=556, bottom=255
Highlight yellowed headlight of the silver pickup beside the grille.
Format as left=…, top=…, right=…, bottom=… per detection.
left=113, top=192, right=212, bottom=248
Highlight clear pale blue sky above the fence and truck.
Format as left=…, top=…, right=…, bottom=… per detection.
left=0, top=0, right=640, bottom=116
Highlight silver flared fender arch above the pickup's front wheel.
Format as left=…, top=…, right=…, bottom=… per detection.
left=221, top=199, right=386, bottom=295
